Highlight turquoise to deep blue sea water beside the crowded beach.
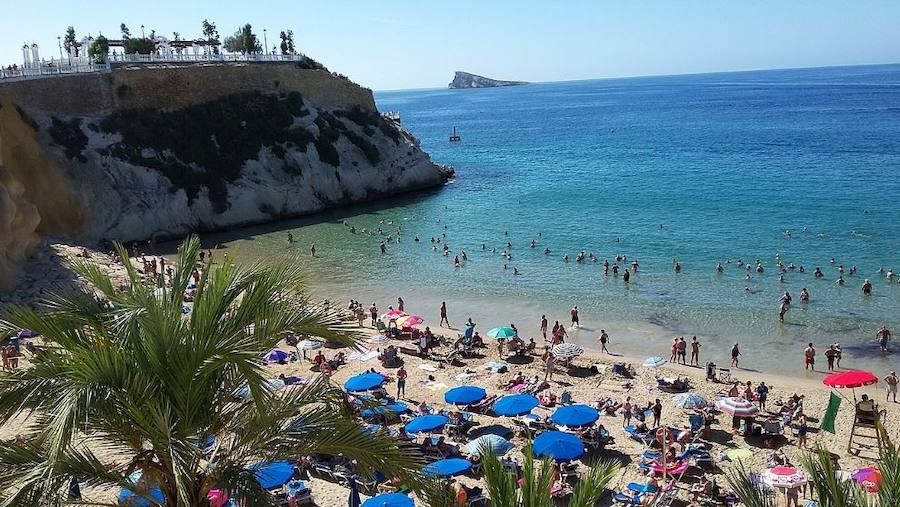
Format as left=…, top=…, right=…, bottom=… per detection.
left=213, top=65, right=900, bottom=370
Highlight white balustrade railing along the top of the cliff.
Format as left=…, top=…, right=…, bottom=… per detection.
left=0, top=53, right=306, bottom=81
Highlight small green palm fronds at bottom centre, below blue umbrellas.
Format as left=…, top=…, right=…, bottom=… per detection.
left=425, top=446, right=620, bottom=507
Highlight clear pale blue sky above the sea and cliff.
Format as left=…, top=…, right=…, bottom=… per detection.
left=0, top=0, right=900, bottom=89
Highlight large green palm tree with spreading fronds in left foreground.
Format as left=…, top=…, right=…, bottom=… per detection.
left=0, top=237, right=420, bottom=507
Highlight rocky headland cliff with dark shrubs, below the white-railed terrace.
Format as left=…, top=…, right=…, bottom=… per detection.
left=0, top=65, right=452, bottom=292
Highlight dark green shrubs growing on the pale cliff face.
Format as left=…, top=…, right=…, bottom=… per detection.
left=98, top=92, right=401, bottom=212
